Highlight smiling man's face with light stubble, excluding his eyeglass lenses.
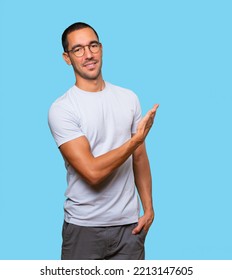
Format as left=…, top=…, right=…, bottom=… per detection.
left=64, top=28, right=102, bottom=80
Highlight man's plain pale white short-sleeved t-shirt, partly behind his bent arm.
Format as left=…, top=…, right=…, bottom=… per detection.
left=48, top=82, right=141, bottom=226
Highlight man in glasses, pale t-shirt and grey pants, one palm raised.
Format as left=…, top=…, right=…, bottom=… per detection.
left=49, top=22, right=158, bottom=260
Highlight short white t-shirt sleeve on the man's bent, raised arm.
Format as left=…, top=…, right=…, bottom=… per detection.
left=48, top=103, right=84, bottom=147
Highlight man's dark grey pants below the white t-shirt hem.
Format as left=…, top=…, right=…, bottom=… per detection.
left=61, top=221, right=146, bottom=260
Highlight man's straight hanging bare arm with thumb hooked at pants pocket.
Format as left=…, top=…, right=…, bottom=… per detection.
left=133, top=144, right=154, bottom=234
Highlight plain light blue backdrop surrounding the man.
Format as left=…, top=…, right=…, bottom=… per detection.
left=0, top=0, right=232, bottom=259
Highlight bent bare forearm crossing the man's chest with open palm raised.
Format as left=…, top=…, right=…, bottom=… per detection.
left=60, top=105, right=158, bottom=186
